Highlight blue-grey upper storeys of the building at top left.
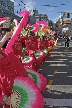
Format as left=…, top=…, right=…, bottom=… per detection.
left=0, top=0, right=19, bottom=19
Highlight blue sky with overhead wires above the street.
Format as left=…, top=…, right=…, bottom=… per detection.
left=11, top=0, right=72, bottom=22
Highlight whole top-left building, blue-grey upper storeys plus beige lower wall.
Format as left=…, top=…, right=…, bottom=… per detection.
left=0, top=0, right=21, bottom=28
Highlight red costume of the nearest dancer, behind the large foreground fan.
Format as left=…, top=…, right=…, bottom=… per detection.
left=0, top=51, right=28, bottom=95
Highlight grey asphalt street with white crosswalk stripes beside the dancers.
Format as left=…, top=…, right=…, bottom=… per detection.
left=40, top=39, right=72, bottom=108
